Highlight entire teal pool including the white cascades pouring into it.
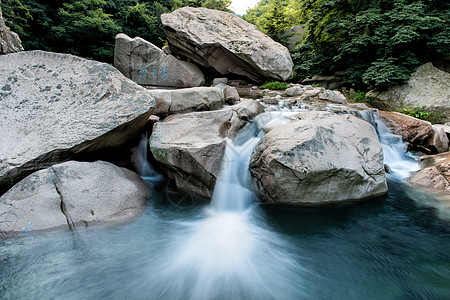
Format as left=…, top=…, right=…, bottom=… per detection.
left=0, top=110, right=450, bottom=300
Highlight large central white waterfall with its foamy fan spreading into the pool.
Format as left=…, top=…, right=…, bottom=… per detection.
left=144, top=114, right=305, bottom=300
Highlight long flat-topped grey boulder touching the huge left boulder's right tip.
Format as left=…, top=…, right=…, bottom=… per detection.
left=145, top=87, right=224, bottom=116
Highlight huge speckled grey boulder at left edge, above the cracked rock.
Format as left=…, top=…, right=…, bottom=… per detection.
left=0, top=51, right=156, bottom=195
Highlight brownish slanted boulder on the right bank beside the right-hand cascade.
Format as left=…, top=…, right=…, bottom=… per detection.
left=380, top=111, right=433, bottom=146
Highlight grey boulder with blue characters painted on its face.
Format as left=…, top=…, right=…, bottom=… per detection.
left=114, top=33, right=205, bottom=88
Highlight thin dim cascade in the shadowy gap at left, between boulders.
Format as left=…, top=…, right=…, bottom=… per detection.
left=131, top=133, right=164, bottom=184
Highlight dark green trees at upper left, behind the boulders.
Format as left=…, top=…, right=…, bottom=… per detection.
left=0, top=0, right=231, bottom=62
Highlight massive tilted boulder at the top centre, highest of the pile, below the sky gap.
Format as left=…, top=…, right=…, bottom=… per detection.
left=161, top=7, right=294, bottom=81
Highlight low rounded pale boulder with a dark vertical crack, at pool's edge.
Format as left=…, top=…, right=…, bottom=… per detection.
left=0, top=161, right=150, bottom=235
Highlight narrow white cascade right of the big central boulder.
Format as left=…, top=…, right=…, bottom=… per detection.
left=358, top=110, right=419, bottom=180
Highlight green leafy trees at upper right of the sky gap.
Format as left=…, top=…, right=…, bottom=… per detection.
left=244, top=0, right=450, bottom=89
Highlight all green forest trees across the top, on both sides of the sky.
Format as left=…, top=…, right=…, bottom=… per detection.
left=1, top=0, right=450, bottom=89
